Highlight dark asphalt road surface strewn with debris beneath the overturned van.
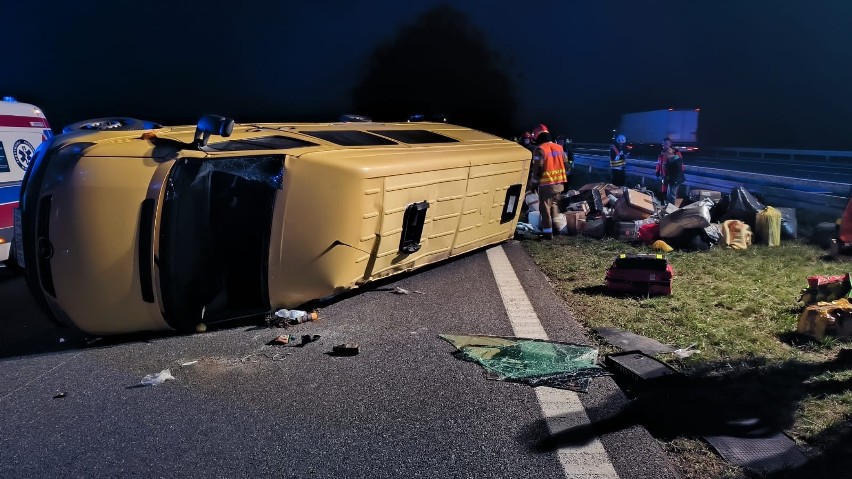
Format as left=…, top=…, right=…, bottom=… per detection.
left=0, top=242, right=677, bottom=479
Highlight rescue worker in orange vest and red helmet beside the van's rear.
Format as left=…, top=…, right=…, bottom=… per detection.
left=529, top=125, right=567, bottom=240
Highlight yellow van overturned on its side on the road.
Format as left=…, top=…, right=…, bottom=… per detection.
left=15, top=115, right=530, bottom=334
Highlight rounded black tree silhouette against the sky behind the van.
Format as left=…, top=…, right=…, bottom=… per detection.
left=353, top=5, right=517, bottom=137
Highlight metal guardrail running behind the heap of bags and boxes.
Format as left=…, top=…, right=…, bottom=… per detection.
left=574, top=152, right=852, bottom=220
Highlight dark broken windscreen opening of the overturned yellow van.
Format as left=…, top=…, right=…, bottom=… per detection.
left=157, top=156, right=284, bottom=330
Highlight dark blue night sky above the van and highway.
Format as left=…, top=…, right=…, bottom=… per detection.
left=0, top=0, right=852, bottom=149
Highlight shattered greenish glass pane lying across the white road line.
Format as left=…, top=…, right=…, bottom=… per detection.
left=439, top=334, right=609, bottom=392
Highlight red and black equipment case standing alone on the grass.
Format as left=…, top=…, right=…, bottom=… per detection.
left=606, top=254, right=674, bottom=295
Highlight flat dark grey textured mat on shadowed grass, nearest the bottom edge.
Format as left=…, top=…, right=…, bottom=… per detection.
left=704, top=433, right=808, bottom=474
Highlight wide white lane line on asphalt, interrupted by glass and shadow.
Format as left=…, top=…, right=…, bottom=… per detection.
left=486, top=246, right=618, bottom=479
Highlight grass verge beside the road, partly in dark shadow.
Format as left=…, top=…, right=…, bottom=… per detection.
left=524, top=237, right=852, bottom=478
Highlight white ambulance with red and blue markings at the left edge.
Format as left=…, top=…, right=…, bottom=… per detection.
left=0, top=96, right=52, bottom=263
